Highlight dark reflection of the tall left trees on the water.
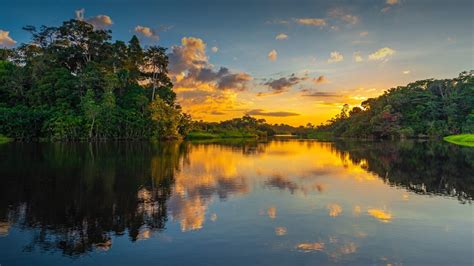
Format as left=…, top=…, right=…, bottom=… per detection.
left=0, top=142, right=187, bottom=256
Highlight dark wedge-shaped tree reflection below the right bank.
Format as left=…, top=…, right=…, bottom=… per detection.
left=333, top=141, right=474, bottom=203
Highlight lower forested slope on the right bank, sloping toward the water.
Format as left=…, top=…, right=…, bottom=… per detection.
left=317, top=71, right=474, bottom=138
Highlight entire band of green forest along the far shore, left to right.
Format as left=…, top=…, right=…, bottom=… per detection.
left=0, top=19, right=474, bottom=143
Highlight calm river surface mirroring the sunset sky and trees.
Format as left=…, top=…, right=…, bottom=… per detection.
left=0, top=140, right=474, bottom=266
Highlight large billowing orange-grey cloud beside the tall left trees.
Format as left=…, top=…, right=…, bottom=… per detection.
left=169, top=37, right=253, bottom=119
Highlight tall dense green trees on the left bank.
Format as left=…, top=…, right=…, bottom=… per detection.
left=0, top=20, right=191, bottom=140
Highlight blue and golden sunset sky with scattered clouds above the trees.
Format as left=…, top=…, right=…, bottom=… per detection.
left=0, top=0, right=474, bottom=125
